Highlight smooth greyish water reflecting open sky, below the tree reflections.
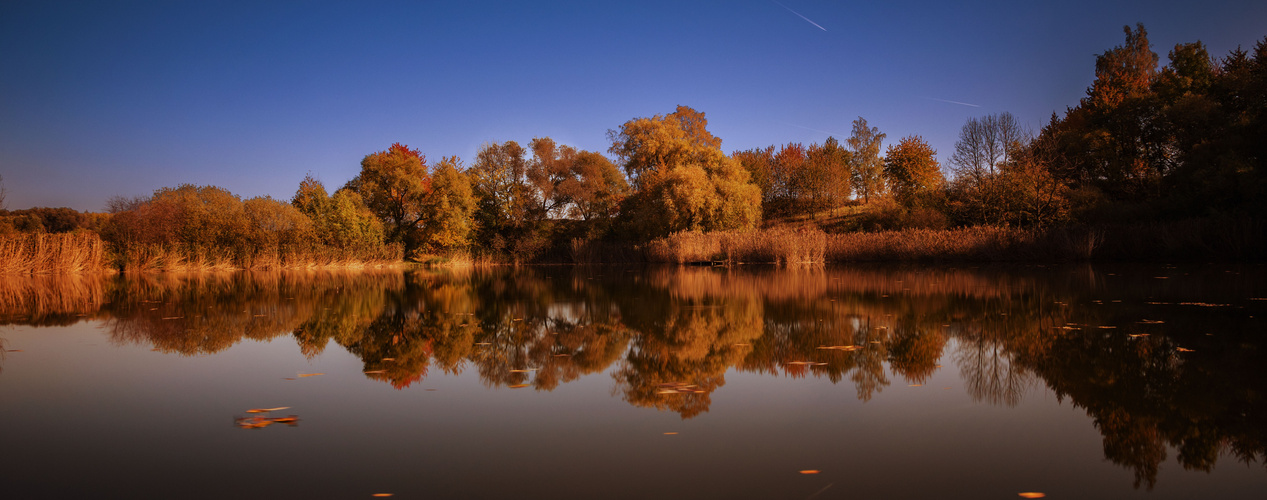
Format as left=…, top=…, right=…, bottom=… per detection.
left=0, top=323, right=1267, bottom=499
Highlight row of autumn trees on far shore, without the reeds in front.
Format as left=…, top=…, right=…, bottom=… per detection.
left=7, top=25, right=1267, bottom=261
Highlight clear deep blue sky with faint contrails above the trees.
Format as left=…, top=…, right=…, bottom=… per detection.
left=0, top=0, right=1267, bottom=210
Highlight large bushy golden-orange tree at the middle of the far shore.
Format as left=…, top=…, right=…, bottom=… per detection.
left=608, top=106, right=761, bottom=237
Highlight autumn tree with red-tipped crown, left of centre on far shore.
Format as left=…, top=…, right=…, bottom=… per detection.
left=352, top=143, right=431, bottom=256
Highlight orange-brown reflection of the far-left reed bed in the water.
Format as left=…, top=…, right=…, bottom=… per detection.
left=0, top=275, right=114, bottom=327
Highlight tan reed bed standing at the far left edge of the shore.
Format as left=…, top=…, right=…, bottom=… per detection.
left=0, top=232, right=110, bottom=275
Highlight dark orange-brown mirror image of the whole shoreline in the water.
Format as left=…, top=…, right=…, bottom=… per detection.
left=0, top=266, right=1267, bottom=487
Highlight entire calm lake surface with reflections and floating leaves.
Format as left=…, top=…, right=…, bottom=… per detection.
left=0, top=265, right=1267, bottom=499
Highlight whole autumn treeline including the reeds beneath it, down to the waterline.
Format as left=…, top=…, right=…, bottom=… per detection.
left=0, top=25, right=1267, bottom=268
